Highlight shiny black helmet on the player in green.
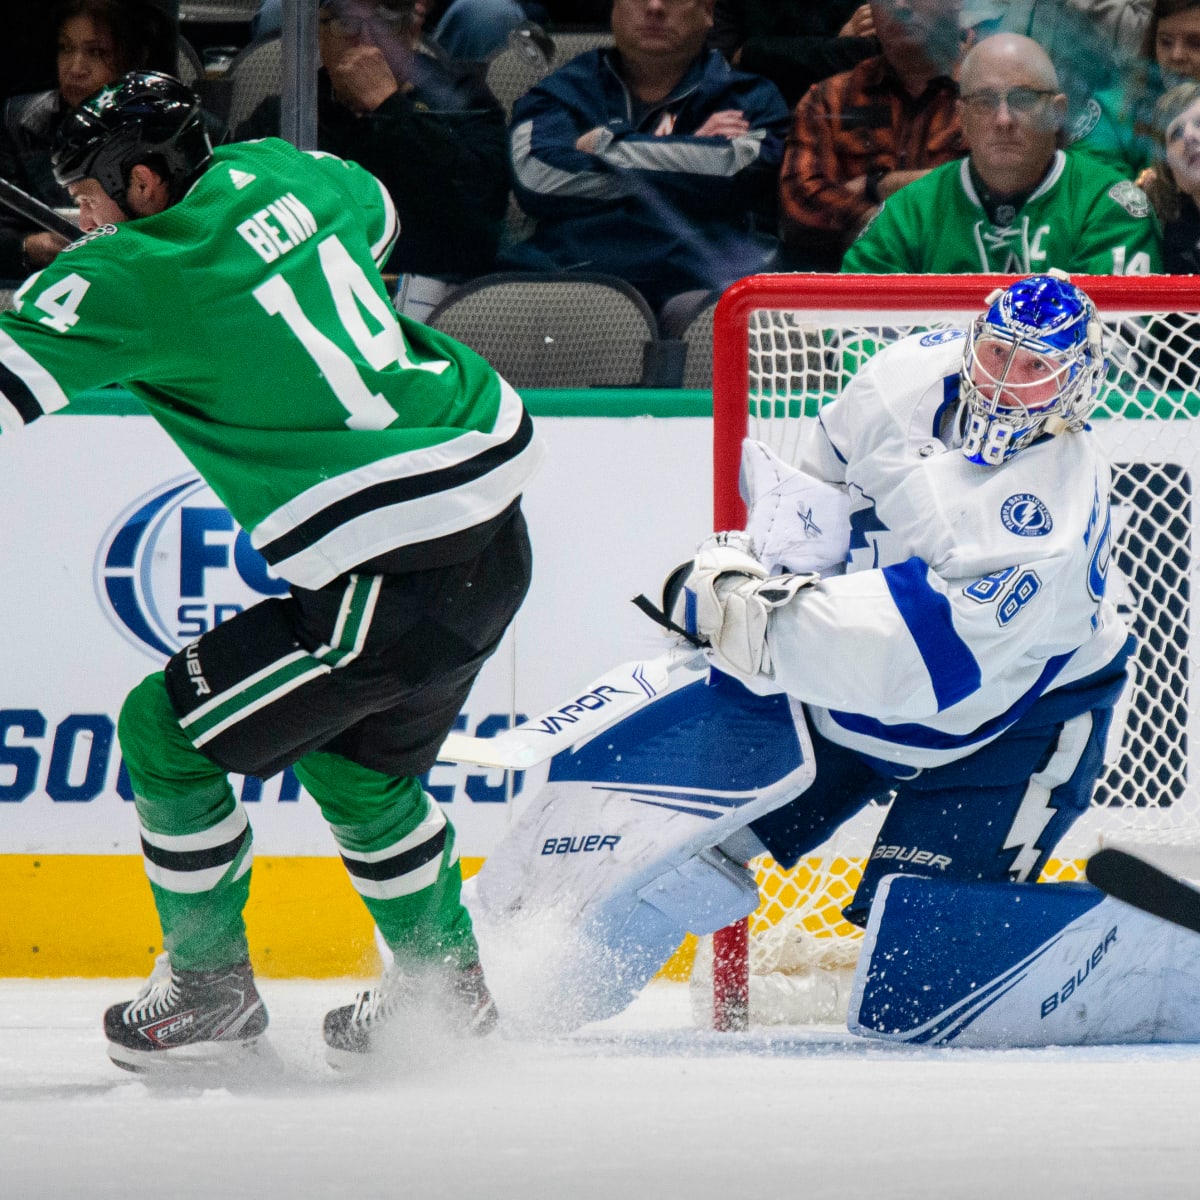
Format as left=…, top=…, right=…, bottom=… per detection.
left=50, top=71, right=212, bottom=211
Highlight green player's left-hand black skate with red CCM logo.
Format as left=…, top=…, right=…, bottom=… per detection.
left=104, top=954, right=268, bottom=1072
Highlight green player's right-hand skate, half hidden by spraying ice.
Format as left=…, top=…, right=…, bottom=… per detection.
left=325, top=962, right=499, bottom=1069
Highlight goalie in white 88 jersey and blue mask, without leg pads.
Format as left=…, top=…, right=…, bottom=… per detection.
left=665, top=275, right=1133, bottom=924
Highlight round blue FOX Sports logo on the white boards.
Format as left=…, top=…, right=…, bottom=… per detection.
left=95, top=475, right=288, bottom=661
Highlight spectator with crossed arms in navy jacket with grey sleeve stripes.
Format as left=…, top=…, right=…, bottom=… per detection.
left=505, top=0, right=787, bottom=308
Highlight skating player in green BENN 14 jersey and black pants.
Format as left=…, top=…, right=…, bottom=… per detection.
left=0, top=72, right=539, bottom=1070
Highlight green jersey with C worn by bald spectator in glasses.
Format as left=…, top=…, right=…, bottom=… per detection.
left=841, top=150, right=1162, bottom=275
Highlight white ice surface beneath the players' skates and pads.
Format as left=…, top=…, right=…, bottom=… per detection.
left=0, top=979, right=1200, bottom=1200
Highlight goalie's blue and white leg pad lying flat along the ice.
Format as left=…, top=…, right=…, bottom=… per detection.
left=848, top=875, right=1200, bottom=1049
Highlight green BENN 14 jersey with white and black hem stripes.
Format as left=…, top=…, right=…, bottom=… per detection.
left=0, top=138, right=540, bottom=588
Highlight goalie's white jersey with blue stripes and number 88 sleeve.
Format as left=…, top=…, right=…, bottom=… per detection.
left=768, top=330, right=1128, bottom=767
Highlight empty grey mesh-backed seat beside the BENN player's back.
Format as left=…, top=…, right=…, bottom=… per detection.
left=426, top=271, right=678, bottom=388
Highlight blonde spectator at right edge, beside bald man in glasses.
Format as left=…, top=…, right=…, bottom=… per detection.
left=1146, top=80, right=1200, bottom=267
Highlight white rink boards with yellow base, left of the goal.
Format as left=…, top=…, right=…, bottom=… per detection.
left=0, top=391, right=712, bottom=977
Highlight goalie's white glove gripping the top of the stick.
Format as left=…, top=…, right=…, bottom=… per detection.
left=662, top=530, right=821, bottom=676
